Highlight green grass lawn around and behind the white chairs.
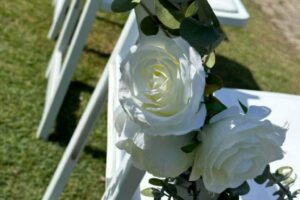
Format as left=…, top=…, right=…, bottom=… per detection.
left=0, top=0, right=300, bottom=200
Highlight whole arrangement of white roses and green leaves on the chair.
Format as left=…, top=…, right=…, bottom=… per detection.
left=112, top=0, right=299, bottom=200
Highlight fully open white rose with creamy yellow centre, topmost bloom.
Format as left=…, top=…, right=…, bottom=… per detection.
left=119, top=36, right=206, bottom=136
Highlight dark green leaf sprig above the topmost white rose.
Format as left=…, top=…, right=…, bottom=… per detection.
left=112, top=0, right=225, bottom=56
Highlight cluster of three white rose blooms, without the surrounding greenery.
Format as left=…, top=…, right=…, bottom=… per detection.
left=116, top=36, right=286, bottom=193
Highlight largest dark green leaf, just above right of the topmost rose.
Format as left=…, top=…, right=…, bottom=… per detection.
left=180, top=17, right=224, bottom=56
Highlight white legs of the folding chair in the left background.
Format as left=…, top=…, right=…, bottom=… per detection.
left=37, top=0, right=112, bottom=139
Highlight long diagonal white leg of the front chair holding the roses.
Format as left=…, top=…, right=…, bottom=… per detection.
left=43, top=12, right=137, bottom=200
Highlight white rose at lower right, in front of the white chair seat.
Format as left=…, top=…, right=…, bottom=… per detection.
left=190, top=106, right=287, bottom=193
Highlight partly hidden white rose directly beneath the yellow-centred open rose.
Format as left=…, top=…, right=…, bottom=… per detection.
left=116, top=109, right=196, bottom=177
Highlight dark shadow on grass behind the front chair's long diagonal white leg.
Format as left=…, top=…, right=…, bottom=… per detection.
left=49, top=81, right=106, bottom=159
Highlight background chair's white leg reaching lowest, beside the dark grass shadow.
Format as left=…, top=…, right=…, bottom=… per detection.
left=37, top=0, right=99, bottom=139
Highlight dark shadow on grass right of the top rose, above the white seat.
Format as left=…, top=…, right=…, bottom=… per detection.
left=212, top=55, right=260, bottom=90
